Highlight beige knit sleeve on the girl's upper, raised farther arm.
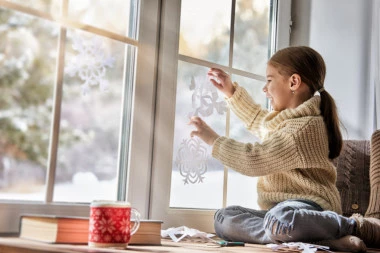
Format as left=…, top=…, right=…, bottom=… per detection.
left=226, top=82, right=269, bottom=138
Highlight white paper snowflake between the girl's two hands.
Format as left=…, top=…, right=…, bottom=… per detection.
left=189, top=76, right=227, bottom=117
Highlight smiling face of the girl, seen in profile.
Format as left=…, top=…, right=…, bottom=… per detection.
left=263, top=64, right=293, bottom=111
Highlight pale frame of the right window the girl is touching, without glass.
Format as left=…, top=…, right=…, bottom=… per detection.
left=145, top=0, right=291, bottom=232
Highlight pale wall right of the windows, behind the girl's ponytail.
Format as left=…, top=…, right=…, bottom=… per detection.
left=290, top=0, right=373, bottom=139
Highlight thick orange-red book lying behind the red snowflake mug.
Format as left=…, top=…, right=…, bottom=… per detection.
left=19, top=214, right=162, bottom=245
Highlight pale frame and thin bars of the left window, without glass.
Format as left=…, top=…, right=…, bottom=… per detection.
left=0, top=0, right=160, bottom=235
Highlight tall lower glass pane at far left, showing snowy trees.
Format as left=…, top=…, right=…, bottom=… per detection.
left=0, top=9, right=58, bottom=200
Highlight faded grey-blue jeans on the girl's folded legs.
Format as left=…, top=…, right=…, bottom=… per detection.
left=214, top=199, right=356, bottom=244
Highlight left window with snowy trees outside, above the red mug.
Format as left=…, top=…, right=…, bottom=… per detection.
left=0, top=0, right=158, bottom=232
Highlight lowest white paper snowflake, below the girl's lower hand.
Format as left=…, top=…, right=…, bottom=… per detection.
left=175, top=138, right=208, bottom=184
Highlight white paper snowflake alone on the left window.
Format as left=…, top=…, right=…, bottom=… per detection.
left=66, top=35, right=115, bottom=95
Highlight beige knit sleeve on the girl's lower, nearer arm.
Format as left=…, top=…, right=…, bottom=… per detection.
left=212, top=132, right=302, bottom=176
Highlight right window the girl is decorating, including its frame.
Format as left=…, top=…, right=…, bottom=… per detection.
left=151, top=0, right=289, bottom=231
